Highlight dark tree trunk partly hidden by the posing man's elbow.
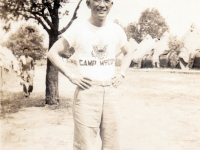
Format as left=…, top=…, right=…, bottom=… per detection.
left=46, top=31, right=59, bottom=105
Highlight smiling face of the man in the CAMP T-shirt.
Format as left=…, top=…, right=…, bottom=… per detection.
left=88, top=0, right=113, bottom=20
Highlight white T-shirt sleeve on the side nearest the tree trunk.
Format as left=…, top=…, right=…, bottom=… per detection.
left=62, top=23, right=78, bottom=47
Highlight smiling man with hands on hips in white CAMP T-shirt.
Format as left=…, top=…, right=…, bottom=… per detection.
left=47, top=0, right=132, bottom=150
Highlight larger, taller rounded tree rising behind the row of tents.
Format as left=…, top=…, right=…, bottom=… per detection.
left=138, top=8, right=169, bottom=39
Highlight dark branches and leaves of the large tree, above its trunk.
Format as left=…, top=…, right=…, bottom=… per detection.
left=0, top=0, right=82, bottom=36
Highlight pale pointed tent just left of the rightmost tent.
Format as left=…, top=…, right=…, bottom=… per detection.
left=153, top=32, right=170, bottom=64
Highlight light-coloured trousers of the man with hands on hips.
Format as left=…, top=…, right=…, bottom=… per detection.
left=73, top=86, right=120, bottom=150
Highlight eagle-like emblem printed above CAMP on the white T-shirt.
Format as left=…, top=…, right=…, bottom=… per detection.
left=92, top=45, right=108, bottom=59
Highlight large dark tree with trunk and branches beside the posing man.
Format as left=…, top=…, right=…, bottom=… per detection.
left=0, top=0, right=82, bottom=105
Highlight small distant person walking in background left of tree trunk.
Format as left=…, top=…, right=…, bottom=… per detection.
left=19, top=48, right=35, bottom=97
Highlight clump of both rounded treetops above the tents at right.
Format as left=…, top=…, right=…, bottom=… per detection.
left=124, top=8, right=169, bottom=43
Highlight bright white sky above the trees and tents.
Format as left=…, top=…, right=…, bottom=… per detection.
left=0, top=0, right=200, bottom=44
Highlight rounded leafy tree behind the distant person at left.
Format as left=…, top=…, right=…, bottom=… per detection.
left=3, top=25, right=46, bottom=60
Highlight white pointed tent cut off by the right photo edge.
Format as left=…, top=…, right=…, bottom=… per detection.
left=179, top=24, right=200, bottom=63
